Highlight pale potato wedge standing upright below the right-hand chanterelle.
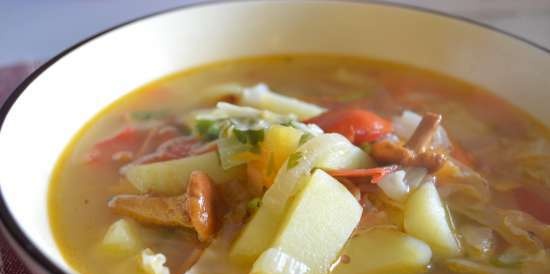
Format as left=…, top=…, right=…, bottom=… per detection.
left=404, top=183, right=460, bottom=257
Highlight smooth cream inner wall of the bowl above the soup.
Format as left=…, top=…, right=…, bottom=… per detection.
left=0, top=1, right=550, bottom=273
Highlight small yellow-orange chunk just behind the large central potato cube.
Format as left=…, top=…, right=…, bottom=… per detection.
left=249, top=125, right=303, bottom=187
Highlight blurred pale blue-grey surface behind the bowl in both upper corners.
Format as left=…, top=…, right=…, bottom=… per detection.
left=0, top=0, right=550, bottom=66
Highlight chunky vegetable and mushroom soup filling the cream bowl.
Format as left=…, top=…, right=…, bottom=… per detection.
left=49, top=55, right=550, bottom=274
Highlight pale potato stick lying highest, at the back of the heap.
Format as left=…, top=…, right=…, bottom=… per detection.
left=241, top=84, right=325, bottom=120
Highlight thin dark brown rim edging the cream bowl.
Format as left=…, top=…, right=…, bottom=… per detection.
left=0, top=0, right=550, bottom=274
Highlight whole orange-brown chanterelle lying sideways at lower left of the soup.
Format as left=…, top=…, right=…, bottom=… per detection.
left=109, top=171, right=216, bottom=241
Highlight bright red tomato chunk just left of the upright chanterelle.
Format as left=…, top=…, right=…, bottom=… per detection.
left=306, top=109, right=393, bottom=145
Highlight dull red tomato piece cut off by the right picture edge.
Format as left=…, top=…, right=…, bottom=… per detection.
left=514, top=187, right=550, bottom=224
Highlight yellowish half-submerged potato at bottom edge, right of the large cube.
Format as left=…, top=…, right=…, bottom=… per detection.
left=332, top=228, right=432, bottom=274
